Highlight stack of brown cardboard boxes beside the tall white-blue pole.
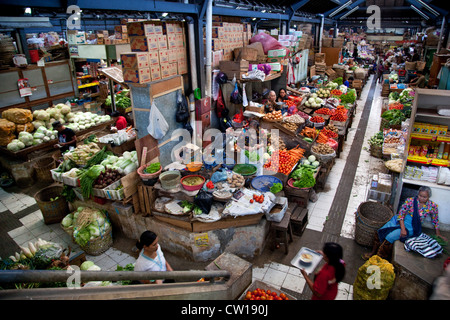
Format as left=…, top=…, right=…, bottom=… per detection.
left=121, top=20, right=188, bottom=83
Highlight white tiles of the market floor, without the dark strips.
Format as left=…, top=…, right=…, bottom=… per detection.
left=0, top=75, right=381, bottom=300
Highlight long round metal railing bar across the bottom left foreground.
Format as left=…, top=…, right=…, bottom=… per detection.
left=0, top=270, right=231, bottom=286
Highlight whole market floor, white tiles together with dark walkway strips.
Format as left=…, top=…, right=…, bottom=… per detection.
left=0, top=77, right=414, bottom=300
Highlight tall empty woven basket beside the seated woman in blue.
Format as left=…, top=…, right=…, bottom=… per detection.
left=355, top=201, right=394, bottom=247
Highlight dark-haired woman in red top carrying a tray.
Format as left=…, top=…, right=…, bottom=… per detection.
left=300, top=242, right=345, bottom=300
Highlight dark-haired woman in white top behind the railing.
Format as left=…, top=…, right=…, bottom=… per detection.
left=134, top=231, right=173, bottom=284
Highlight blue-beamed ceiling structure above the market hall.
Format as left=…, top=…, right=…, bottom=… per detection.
left=1, top=0, right=449, bottom=28
